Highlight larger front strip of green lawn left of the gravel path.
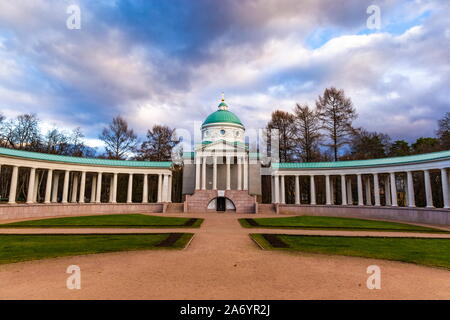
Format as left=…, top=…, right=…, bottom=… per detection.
left=0, top=233, right=193, bottom=264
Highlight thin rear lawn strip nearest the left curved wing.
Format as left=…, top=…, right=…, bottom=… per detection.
left=0, top=214, right=203, bottom=228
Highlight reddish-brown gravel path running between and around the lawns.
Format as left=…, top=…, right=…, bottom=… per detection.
left=0, top=214, right=450, bottom=299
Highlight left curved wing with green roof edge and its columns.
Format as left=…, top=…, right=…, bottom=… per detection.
left=0, top=148, right=172, bottom=204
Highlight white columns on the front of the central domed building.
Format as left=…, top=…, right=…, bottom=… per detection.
left=195, top=154, right=248, bottom=190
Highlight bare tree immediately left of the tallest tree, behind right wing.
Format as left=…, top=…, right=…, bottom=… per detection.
left=294, top=104, right=322, bottom=162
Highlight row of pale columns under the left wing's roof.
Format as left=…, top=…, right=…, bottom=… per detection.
left=0, top=165, right=172, bottom=204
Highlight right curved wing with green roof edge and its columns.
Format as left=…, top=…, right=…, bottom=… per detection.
left=272, top=151, right=450, bottom=209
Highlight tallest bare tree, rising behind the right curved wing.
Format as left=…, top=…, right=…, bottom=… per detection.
left=316, top=87, right=357, bottom=161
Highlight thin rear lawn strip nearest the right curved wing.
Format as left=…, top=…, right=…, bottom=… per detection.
left=239, top=216, right=447, bottom=233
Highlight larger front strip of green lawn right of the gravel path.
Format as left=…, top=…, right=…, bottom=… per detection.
left=250, top=234, right=450, bottom=269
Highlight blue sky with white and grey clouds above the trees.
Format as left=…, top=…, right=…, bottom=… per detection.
left=0, top=0, right=450, bottom=146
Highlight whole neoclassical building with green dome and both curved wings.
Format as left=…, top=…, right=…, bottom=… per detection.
left=0, top=99, right=450, bottom=225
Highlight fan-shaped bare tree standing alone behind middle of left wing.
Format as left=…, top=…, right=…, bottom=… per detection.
left=100, top=116, right=137, bottom=159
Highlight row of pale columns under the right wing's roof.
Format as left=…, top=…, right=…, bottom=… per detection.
left=272, top=168, right=450, bottom=209
